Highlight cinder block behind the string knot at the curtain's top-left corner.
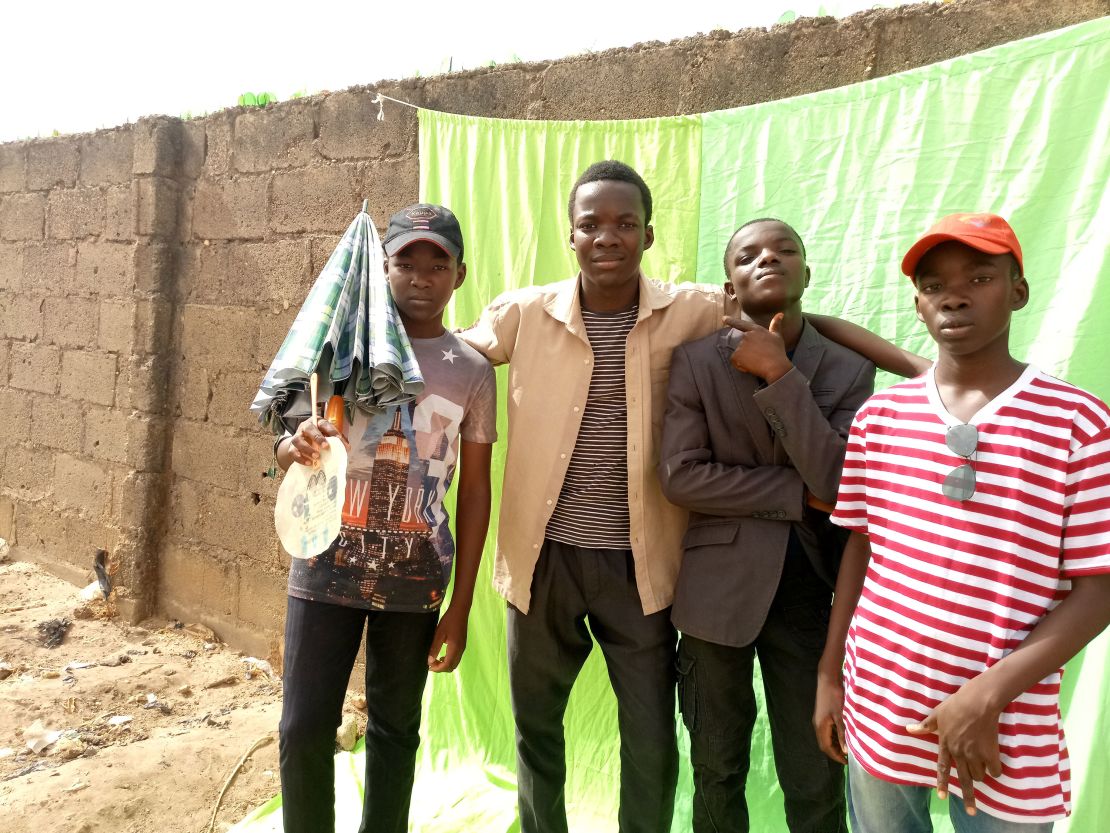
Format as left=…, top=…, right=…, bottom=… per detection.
left=319, top=89, right=417, bottom=160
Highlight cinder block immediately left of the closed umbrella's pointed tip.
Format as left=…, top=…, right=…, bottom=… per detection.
left=270, top=163, right=363, bottom=233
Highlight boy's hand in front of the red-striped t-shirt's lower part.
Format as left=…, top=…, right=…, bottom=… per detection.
left=906, top=681, right=1002, bottom=815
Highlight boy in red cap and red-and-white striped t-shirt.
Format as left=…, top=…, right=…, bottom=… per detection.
left=814, top=214, right=1110, bottom=833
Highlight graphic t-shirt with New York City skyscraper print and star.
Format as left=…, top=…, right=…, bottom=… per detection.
left=289, top=333, right=497, bottom=612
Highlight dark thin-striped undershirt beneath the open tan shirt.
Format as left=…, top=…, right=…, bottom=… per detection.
left=547, top=307, right=639, bottom=550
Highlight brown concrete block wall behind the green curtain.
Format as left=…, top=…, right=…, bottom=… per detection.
left=0, top=0, right=1110, bottom=652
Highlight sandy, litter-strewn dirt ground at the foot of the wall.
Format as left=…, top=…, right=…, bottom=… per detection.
left=0, top=562, right=328, bottom=833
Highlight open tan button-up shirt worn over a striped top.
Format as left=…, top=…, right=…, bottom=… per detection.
left=457, top=275, right=737, bottom=614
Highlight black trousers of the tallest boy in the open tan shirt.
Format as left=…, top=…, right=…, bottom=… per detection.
left=508, top=541, right=678, bottom=833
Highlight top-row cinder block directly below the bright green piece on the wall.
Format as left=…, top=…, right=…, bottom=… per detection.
left=232, top=102, right=316, bottom=173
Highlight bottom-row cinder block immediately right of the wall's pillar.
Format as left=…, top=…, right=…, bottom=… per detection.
left=158, top=543, right=239, bottom=621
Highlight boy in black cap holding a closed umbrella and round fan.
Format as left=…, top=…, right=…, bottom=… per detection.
left=276, top=204, right=496, bottom=833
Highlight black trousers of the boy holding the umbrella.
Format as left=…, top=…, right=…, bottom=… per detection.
left=279, top=596, right=438, bottom=833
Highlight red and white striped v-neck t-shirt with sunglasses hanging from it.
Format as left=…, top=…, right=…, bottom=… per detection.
left=833, top=367, right=1110, bottom=822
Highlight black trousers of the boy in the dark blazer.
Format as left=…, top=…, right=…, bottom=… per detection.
left=678, top=564, right=848, bottom=833
